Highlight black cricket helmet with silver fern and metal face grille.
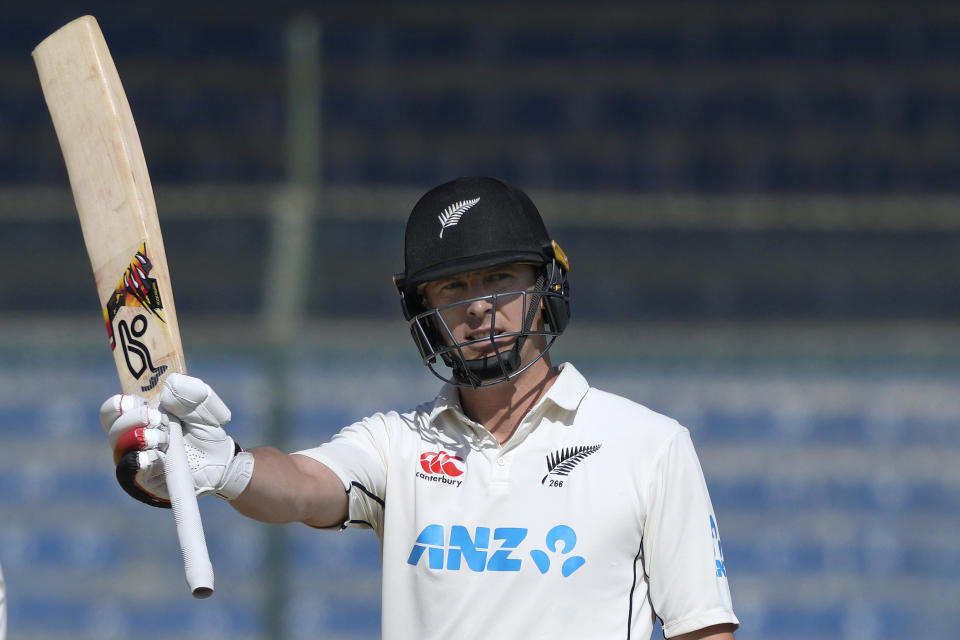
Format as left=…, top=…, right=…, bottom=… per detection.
left=393, top=176, right=570, bottom=388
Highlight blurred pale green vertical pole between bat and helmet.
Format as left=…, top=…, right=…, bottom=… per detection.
left=262, top=17, right=322, bottom=640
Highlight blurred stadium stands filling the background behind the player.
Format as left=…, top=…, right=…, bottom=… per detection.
left=0, top=0, right=960, bottom=640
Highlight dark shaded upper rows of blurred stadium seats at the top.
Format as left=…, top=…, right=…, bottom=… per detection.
left=0, top=3, right=960, bottom=193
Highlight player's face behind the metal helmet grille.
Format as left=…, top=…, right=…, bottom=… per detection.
left=423, top=263, right=541, bottom=360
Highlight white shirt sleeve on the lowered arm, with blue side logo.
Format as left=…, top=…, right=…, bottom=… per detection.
left=643, top=429, right=739, bottom=638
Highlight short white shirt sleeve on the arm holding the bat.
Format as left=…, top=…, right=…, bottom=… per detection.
left=296, top=414, right=389, bottom=532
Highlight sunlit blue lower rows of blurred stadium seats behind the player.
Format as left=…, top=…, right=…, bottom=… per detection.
left=0, top=353, right=960, bottom=640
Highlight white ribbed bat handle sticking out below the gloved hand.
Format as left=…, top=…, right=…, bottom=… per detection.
left=164, top=420, right=213, bottom=598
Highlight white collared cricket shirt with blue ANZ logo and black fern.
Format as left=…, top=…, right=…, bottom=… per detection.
left=299, top=364, right=738, bottom=640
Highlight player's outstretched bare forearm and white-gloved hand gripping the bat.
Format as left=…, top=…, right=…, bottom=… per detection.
left=100, top=374, right=348, bottom=528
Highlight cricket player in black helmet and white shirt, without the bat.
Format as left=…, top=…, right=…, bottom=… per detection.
left=101, top=177, right=739, bottom=640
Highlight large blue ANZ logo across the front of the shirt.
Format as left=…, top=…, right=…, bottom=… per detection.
left=407, top=524, right=586, bottom=578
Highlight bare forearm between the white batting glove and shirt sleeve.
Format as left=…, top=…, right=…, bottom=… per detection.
left=230, top=447, right=347, bottom=527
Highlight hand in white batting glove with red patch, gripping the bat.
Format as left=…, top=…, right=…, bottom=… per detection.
left=100, top=373, right=253, bottom=508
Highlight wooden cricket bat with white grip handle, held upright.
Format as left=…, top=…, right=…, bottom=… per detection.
left=33, top=16, right=213, bottom=598
